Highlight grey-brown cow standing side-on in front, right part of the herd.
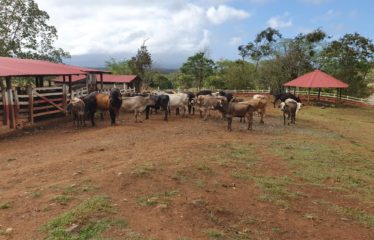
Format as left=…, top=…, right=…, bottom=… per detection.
left=217, top=101, right=254, bottom=131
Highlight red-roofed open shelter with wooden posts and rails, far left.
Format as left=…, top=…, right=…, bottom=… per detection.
left=0, top=57, right=106, bottom=128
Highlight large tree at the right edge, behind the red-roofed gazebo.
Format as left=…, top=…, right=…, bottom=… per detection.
left=323, top=33, right=374, bottom=96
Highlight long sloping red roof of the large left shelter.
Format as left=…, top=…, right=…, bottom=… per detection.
left=0, top=57, right=106, bottom=77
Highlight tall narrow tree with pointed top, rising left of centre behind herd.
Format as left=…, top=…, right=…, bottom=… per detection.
left=129, top=41, right=152, bottom=86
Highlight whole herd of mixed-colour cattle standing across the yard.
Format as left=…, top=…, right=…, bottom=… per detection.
left=67, top=88, right=301, bottom=131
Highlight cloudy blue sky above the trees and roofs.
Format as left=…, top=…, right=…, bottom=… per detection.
left=35, top=0, right=374, bottom=68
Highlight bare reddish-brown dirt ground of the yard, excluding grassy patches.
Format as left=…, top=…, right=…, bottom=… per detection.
left=0, top=103, right=374, bottom=240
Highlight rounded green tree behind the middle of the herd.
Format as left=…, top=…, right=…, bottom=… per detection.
left=181, top=52, right=215, bottom=88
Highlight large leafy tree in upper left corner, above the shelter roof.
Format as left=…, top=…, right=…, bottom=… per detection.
left=0, top=0, right=70, bottom=62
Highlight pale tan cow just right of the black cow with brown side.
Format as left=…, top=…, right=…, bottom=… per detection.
left=122, top=95, right=156, bottom=122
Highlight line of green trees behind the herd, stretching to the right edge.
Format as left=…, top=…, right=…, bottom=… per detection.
left=107, top=28, right=374, bottom=97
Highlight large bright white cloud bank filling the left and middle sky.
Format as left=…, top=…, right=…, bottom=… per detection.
left=36, top=0, right=249, bottom=59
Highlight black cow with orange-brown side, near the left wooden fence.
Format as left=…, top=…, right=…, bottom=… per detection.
left=83, top=88, right=122, bottom=126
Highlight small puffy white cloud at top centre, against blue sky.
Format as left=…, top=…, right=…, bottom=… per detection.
left=206, top=5, right=250, bottom=24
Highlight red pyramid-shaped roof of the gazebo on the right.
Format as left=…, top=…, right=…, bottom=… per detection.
left=283, top=70, right=348, bottom=88
